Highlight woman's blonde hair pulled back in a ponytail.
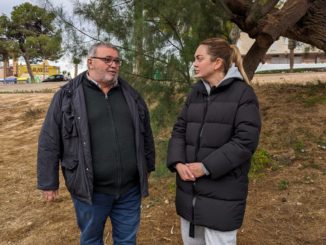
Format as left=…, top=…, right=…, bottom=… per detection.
left=199, top=38, right=249, bottom=83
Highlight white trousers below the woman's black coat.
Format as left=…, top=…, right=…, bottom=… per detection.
left=180, top=217, right=237, bottom=245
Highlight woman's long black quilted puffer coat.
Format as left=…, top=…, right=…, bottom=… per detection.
left=167, top=68, right=261, bottom=231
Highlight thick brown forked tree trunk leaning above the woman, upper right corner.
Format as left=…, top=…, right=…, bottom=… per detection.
left=214, top=0, right=326, bottom=79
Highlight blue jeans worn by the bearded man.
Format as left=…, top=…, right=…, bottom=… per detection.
left=72, top=186, right=141, bottom=245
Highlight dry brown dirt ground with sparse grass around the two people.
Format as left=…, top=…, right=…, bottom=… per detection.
left=0, top=73, right=326, bottom=245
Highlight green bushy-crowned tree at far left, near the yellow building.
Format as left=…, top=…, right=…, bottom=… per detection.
left=1, top=2, right=61, bottom=81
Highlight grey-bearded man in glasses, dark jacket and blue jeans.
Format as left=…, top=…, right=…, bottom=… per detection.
left=37, top=43, right=155, bottom=245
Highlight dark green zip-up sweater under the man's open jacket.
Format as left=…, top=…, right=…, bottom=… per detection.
left=83, top=77, right=139, bottom=195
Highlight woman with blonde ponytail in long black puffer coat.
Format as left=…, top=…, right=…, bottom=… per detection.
left=167, top=38, right=261, bottom=245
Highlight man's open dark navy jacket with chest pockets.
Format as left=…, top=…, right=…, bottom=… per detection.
left=37, top=72, right=155, bottom=203
